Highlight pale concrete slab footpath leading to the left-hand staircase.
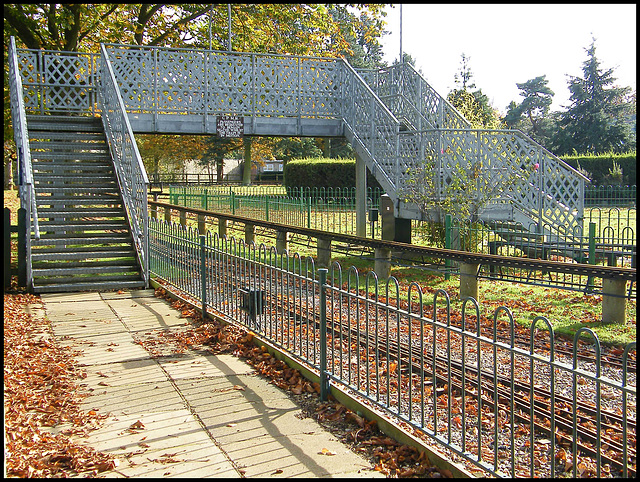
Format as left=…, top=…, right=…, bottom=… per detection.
left=30, top=290, right=382, bottom=477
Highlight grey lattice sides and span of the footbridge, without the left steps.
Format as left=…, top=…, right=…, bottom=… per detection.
left=9, top=39, right=588, bottom=290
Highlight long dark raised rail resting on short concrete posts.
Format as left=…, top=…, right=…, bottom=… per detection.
left=148, top=200, right=636, bottom=281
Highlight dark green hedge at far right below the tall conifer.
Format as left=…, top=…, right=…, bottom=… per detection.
left=561, top=151, right=636, bottom=186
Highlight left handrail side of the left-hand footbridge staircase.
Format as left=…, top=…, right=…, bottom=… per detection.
left=8, top=37, right=40, bottom=286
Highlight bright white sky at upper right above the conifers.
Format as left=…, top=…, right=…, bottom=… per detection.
left=381, top=4, right=636, bottom=113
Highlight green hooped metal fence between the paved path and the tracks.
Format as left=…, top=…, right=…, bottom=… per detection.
left=150, top=220, right=636, bottom=477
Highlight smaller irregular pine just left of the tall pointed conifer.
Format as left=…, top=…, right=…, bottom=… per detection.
left=504, top=75, right=554, bottom=145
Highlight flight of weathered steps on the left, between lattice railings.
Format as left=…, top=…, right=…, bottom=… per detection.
left=27, top=115, right=145, bottom=293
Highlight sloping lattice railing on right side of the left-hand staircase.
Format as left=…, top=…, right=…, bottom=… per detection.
left=98, top=46, right=149, bottom=286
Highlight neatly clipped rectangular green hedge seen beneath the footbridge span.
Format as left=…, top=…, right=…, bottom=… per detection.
left=284, top=158, right=380, bottom=188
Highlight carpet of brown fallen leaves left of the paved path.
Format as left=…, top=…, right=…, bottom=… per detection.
left=4, top=294, right=115, bottom=477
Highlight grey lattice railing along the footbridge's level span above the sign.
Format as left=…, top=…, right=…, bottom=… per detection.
left=106, top=44, right=341, bottom=118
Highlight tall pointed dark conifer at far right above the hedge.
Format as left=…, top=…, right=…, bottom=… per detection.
left=553, top=39, right=635, bottom=155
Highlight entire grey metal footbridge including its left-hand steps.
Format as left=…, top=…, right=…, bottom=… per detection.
left=9, top=38, right=587, bottom=292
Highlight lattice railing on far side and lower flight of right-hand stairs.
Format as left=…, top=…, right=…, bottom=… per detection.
left=360, top=63, right=588, bottom=236
